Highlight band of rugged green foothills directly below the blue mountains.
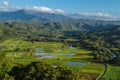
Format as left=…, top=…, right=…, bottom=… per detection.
left=0, top=20, right=119, bottom=39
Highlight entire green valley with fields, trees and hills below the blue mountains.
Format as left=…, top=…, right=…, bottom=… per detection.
left=0, top=21, right=120, bottom=80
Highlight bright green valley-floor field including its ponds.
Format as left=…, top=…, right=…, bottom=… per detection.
left=0, top=40, right=104, bottom=80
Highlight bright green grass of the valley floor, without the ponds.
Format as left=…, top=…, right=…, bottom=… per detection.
left=0, top=40, right=104, bottom=79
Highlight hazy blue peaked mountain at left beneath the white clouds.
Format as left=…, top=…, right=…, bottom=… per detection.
left=0, top=10, right=71, bottom=21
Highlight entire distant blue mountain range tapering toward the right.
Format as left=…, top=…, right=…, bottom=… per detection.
left=0, top=10, right=119, bottom=21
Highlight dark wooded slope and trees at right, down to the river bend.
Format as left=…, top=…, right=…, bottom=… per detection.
left=81, top=26, right=120, bottom=63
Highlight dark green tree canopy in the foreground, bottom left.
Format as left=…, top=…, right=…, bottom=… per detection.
left=0, top=62, right=79, bottom=80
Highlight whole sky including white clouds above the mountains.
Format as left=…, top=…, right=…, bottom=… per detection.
left=0, top=0, right=120, bottom=18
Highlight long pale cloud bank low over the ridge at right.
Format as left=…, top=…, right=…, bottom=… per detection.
left=68, top=12, right=120, bottom=21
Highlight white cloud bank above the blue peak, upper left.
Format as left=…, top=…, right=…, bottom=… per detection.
left=0, top=1, right=65, bottom=14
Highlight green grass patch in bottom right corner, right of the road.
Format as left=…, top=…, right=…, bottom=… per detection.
left=102, top=65, right=120, bottom=80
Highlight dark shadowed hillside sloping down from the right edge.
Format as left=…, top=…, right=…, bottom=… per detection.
left=86, top=25, right=120, bottom=48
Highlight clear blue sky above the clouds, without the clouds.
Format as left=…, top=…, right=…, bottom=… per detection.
left=0, top=0, right=120, bottom=17
